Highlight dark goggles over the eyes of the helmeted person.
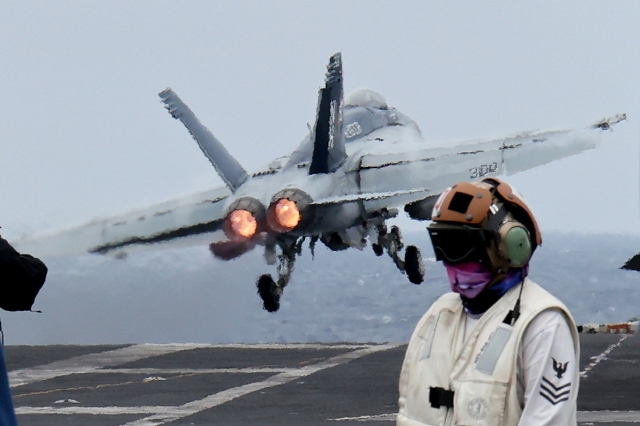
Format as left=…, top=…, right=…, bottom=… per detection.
left=427, top=224, right=499, bottom=264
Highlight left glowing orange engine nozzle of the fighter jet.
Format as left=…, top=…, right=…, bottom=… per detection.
left=223, top=197, right=265, bottom=241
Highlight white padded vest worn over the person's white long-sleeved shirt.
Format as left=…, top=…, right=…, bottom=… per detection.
left=397, top=279, right=579, bottom=426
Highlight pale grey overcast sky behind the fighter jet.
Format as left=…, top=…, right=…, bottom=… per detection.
left=0, top=0, right=640, bottom=237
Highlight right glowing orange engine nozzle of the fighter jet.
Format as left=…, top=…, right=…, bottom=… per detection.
left=267, top=189, right=313, bottom=233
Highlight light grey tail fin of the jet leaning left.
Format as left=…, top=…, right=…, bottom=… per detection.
left=158, top=88, right=249, bottom=192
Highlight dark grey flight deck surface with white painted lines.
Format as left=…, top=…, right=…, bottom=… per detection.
left=5, top=334, right=640, bottom=426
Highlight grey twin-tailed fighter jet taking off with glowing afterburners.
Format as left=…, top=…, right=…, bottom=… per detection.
left=16, top=53, right=625, bottom=312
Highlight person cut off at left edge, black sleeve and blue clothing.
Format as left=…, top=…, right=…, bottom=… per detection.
left=0, top=237, right=47, bottom=426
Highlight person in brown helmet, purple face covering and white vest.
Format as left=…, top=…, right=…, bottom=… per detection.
left=397, top=179, right=579, bottom=426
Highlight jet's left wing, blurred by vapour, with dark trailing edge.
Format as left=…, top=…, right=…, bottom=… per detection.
left=11, top=188, right=231, bottom=258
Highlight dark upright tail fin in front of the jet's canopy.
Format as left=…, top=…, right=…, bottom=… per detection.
left=309, top=53, right=347, bottom=175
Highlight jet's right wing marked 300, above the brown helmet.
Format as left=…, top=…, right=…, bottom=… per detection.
left=359, top=114, right=626, bottom=211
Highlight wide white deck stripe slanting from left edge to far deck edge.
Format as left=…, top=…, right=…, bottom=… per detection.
left=9, top=344, right=208, bottom=388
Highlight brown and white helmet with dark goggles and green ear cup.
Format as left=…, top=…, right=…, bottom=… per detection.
left=427, top=178, right=542, bottom=274
